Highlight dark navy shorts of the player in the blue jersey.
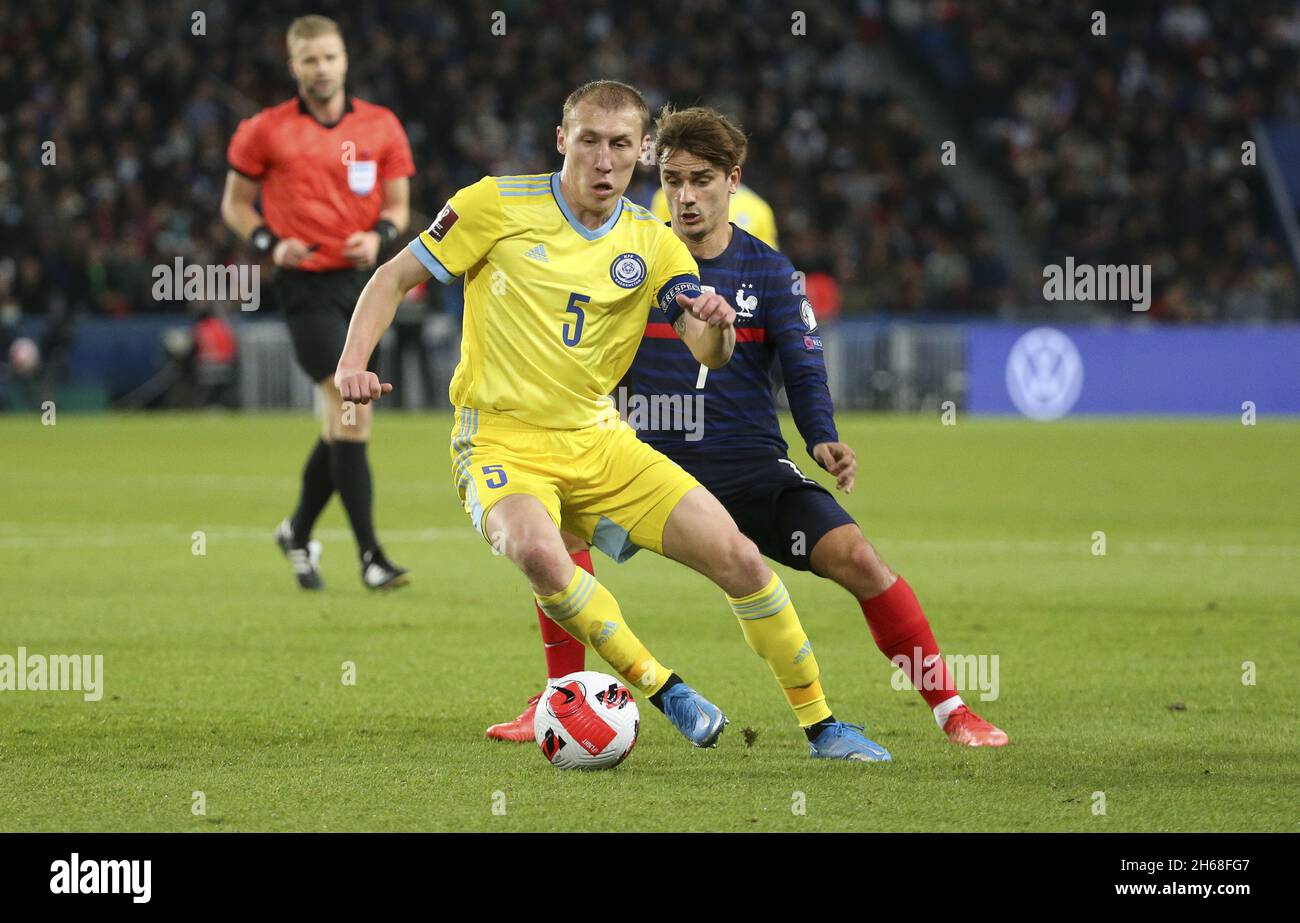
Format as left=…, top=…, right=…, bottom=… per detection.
left=677, top=456, right=854, bottom=571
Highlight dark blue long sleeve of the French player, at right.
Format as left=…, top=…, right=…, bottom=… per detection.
left=767, top=260, right=840, bottom=456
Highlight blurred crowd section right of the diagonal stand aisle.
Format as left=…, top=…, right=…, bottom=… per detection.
left=889, top=0, right=1300, bottom=321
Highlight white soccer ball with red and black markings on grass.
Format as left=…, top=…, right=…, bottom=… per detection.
left=533, top=670, right=641, bottom=770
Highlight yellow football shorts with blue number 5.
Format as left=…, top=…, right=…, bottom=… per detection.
left=451, top=407, right=699, bottom=562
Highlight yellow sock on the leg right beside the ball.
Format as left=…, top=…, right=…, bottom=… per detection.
left=537, top=567, right=672, bottom=696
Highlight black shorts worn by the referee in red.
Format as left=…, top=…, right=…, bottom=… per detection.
left=272, top=267, right=378, bottom=381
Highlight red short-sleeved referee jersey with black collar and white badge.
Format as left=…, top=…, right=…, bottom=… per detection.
left=226, top=96, right=415, bottom=272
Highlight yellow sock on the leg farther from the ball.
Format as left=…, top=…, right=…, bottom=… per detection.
left=727, top=573, right=831, bottom=728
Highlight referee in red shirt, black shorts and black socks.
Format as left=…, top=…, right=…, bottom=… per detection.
left=221, top=16, right=415, bottom=590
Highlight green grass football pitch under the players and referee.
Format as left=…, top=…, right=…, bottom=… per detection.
left=0, top=412, right=1300, bottom=831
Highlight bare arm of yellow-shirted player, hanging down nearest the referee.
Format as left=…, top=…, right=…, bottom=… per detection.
left=334, top=250, right=429, bottom=404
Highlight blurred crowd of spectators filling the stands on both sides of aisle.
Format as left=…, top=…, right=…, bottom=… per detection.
left=0, top=0, right=1300, bottom=325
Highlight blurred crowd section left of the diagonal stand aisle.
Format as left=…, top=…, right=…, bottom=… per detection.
left=0, top=0, right=988, bottom=325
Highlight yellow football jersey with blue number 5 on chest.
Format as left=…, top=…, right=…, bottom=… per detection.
left=410, top=173, right=699, bottom=429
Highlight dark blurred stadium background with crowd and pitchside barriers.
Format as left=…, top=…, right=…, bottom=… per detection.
left=0, top=0, right=1300, bottom=412
